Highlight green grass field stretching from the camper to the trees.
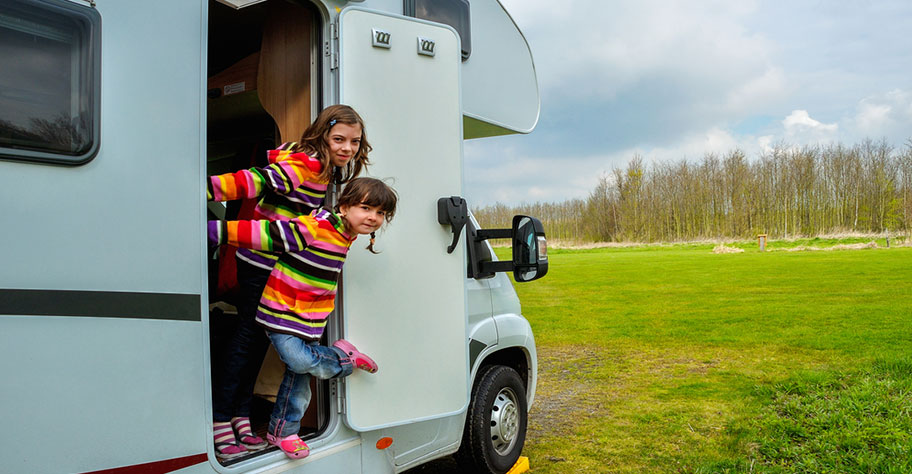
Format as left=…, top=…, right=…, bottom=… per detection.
left=499, top=242, right=912, bottom=474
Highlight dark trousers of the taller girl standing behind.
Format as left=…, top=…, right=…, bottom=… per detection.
left=212, top=259, right=269, bottom=421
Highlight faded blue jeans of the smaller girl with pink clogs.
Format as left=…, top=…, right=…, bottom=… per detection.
left=266, top=331, right=353, bottom=437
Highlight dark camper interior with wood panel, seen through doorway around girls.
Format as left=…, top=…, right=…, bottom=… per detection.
left=207, top=0, right=329, bottom=465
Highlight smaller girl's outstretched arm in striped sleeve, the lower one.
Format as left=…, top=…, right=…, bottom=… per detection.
left=209, top=216, right=316, bottom=252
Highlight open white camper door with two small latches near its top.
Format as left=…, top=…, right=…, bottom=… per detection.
left=339, top=8, right=469, bottom=431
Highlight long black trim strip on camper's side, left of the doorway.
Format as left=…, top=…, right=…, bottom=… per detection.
left=0, top=289, right=202, bottom=321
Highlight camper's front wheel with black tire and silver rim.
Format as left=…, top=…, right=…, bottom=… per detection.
left=456, top=365, right=528, bottom=474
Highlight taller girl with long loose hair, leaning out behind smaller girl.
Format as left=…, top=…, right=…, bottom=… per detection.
left=207, top=105, right=371, bottom=459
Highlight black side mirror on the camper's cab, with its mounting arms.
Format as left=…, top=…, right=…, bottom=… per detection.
left=469, top=215, right=548, bottom=283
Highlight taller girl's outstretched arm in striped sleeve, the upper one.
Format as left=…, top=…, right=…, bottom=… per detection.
left=206, top=150, right=322, bottom=201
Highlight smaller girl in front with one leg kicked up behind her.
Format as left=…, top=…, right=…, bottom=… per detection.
left=209, top=178, right=398, bottom=459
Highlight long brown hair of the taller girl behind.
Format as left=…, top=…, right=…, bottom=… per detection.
left=294, top=104, right=371, bottom=183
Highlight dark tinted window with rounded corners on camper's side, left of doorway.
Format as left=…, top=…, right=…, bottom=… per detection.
left=0, top=0, right=101, bottom=164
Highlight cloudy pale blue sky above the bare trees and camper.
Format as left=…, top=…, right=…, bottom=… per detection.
left=464, top=0, right=912, bottom=207
